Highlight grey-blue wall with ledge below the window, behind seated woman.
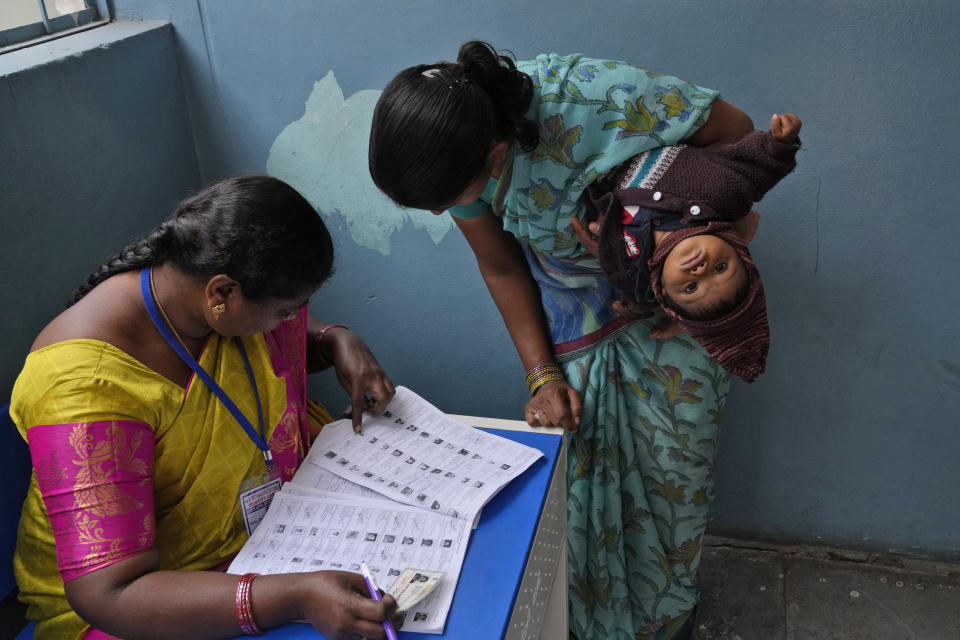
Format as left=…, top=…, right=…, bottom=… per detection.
left=0, top=22, right=200, bottom=404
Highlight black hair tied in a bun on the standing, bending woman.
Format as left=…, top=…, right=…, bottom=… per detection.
left=369, top=40, right=539, bottom=209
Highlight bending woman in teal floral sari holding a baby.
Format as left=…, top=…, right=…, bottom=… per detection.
left=370, top=42, right=753, bottom=640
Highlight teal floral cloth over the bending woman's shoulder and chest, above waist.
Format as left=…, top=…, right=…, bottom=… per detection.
left=493, top=54, right=718, bottom=257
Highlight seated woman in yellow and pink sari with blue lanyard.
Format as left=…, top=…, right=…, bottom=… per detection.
left=10, top=176, right=396, bottom=638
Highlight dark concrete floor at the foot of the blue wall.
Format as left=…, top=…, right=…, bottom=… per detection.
left=693, top=537, right=960, bottom=640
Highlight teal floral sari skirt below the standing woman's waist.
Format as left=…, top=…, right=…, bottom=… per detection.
left=564, top=321, right=729, bottom=640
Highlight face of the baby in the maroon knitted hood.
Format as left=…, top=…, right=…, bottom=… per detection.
left=661, top=234, right=747, bottom=315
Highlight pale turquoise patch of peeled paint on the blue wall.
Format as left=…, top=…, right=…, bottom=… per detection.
left=267, top=71, right=453, bottom=255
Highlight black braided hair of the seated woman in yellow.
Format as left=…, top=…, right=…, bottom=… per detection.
left=71, top=175, right=333, bottom=304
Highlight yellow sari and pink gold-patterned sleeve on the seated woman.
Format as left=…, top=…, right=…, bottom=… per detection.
left=10, top=309, right=309, bottom=639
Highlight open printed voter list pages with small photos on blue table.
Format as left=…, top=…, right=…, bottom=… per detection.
left=228, top=387, right=543, bottom=633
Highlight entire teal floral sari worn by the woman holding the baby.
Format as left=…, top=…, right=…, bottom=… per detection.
left=484, top=55, right=729, bottom=640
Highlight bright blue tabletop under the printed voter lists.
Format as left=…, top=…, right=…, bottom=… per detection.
left=231, top=429, right=563, bottom=640
